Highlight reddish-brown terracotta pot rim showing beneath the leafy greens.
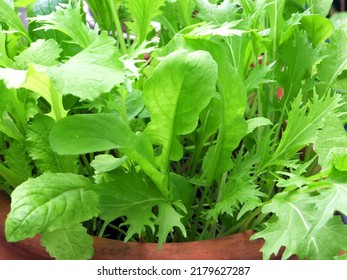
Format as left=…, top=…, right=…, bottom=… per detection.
left=0, top=191, right=270, bottom=260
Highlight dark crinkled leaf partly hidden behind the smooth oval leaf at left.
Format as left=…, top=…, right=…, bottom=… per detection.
left=26, top=115, right=77, bottom=173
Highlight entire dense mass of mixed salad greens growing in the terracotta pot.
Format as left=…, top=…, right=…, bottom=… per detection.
left=0, top=0, right=347, bottom=259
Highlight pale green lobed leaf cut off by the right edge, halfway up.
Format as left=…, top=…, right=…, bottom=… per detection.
left=314, top=115, right=347, bottom=170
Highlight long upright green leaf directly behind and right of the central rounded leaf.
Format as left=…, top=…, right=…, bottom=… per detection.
left=184, top=38, right=247, bottom=180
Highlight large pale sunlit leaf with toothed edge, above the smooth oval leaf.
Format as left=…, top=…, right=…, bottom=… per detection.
left=48, top=33, right=125, bottom=100
